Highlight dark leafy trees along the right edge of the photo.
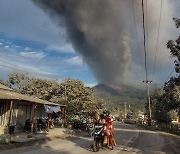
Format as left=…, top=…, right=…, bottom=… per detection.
left=152, top=19, right=180, bottom=123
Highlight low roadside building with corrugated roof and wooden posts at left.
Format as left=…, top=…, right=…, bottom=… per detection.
left=0, top=84, right=66, bottom=134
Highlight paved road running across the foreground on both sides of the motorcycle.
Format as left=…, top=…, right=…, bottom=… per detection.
left=2, top=123, right=180, bottom=154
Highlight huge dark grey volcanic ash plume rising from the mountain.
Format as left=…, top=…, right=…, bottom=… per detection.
left=33, top=0, right=131, bottom=86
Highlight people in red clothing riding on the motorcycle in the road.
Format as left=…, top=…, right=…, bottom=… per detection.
left=99, top=110, right=116, bottom=148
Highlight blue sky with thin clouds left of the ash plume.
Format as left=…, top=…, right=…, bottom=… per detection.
left=0, top=0, right=97, bottom=85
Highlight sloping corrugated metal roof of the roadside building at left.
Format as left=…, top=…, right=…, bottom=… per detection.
left=0, top=84, right=61, bottom=106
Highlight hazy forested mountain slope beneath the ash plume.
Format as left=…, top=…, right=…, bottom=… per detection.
left=93, top=84, right=146, bottom=118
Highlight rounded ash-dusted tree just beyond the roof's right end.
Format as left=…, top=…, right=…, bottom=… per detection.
left=61, top=78, right=99, bottom=114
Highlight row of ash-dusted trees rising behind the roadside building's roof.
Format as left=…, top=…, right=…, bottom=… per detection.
left=8, top=73, right=102, bottom=115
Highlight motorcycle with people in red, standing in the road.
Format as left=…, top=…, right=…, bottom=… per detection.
left=92, top=125, right=104, bottom=152
